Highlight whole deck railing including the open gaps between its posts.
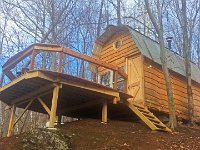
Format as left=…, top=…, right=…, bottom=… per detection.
left=1, top=44, right=127, bottom=93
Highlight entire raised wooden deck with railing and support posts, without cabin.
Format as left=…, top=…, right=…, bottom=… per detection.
left=0, top=44, right=132, bottom=136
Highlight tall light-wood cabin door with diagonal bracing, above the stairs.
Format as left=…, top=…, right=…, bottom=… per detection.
left=126, top=56, right=144, bottom=104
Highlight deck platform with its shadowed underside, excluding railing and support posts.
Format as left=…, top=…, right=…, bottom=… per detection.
left=0, top=70, right=131, bottom=117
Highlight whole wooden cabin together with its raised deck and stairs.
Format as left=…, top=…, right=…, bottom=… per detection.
left=0, top=25, right=200, bottom=136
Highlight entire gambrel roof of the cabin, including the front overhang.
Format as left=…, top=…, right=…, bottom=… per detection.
left=96, top=25, right=200, bottom=83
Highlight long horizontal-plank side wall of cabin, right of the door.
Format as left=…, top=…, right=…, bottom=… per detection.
left=144, top=58, right=200, bottom=122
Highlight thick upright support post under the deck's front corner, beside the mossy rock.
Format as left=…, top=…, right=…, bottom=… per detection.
left=49, top=85, right=60, bottom=128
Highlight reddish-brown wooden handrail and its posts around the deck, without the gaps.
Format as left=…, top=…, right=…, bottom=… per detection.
left=2, top=44, right=128, bottom=92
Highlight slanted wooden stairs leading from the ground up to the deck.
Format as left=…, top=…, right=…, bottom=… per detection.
left=124, top=101, right=172, bottom=132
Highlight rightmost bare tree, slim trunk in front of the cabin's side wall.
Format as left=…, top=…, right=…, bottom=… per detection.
left=171, top=0, right=200, bottom=125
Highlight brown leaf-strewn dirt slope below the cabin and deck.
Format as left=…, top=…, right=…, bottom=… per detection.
left=0, top=119, right=200, bottom=150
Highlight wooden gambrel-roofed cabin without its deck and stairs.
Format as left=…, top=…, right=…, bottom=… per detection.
left=92, top=25, right=200, bottom=122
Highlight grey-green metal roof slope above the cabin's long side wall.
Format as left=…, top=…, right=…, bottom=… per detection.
left=128, top=27, right=200, bottom=83
